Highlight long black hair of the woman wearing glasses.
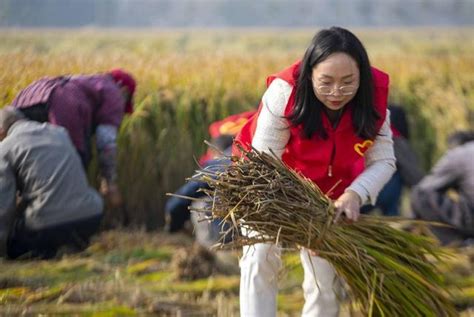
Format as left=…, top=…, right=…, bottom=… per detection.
left=288, top=27, right=380, bottom=139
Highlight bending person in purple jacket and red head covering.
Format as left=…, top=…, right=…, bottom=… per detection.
left=12, top=69, right=136, bottom=207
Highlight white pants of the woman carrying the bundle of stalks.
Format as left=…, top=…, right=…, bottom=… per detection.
left=240, top=243, right=340, bottom=317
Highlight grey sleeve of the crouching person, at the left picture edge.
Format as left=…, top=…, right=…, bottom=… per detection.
left=0, top=154, right=16, bottom=257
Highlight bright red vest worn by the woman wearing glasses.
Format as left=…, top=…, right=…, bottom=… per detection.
left=234, top=61, right=389, bottom=199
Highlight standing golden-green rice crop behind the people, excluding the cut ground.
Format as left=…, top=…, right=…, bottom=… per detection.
left=0, top=28, right=474, bottom=228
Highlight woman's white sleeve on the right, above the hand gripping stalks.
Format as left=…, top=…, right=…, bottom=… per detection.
left=346, top=110, right=396, bottom=205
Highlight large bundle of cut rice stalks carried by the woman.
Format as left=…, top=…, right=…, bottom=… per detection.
left=193, top=146, right=457, bottom=317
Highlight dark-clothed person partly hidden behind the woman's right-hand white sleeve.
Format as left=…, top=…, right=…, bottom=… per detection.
left=361, top=105, right=424, bottom=216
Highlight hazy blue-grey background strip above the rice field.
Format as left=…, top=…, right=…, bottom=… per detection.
left=0, top=0, right=474, bottom=28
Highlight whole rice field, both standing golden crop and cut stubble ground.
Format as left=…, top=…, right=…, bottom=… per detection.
left=0, top=28, right=474, bottom=316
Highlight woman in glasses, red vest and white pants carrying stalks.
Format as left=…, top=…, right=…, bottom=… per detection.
left=236, top=27, right=395, bottom=317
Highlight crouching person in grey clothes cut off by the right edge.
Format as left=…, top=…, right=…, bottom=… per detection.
left=411, top=131, right=474, bottom=245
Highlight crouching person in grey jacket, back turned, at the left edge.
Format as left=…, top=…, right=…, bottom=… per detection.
left=0, top=107, right=103, bottom=259
